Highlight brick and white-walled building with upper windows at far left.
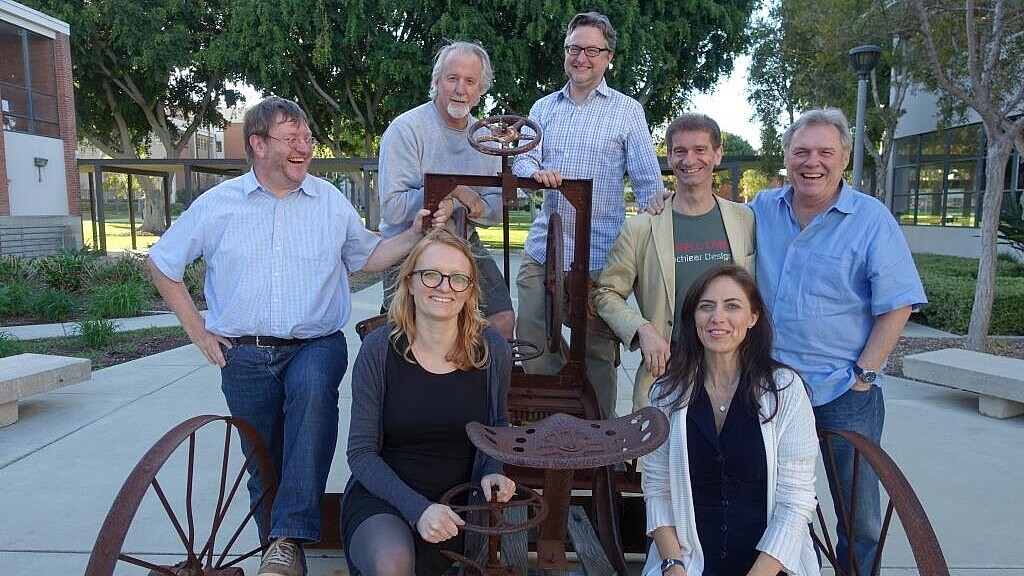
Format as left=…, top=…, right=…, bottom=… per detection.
left=0, top=0, right=82, bottom=255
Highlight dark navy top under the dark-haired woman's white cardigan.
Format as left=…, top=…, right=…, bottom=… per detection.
left=686, top=386, right=768, bottom=576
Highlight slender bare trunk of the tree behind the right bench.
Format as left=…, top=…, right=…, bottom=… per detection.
left=966, top=131, right=1013, bottom=352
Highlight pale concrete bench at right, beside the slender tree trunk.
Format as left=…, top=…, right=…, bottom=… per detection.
left=903, top=348, right=1024, bottom=418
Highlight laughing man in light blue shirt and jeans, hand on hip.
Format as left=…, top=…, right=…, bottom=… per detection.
left=150, top=97, right=447, bottom=576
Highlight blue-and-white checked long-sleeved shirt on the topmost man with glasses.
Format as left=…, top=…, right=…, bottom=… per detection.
left=512, top=80, right=664, bottom=271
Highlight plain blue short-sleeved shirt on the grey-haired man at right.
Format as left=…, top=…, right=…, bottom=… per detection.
left=751, top=182, right=928, bottom=406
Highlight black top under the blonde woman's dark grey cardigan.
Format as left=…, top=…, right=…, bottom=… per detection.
left=381, top=345, right=487, bottom=502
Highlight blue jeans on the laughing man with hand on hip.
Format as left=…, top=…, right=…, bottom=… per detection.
left=220, top=332, right=348, bottom=542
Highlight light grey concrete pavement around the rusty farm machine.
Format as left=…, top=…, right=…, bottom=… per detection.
left=0, top=252, right=1024, bottom=576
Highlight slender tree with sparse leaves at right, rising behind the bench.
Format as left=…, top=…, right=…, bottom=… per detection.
left=902, top=0, right=1024, bottom=351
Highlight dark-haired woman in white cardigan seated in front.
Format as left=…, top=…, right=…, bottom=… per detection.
left=643, top=264, right=819, bottom=576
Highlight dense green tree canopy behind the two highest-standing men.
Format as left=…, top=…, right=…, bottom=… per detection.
left=230, top=0, right=755, bottom=156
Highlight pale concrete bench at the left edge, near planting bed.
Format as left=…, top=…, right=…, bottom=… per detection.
left=0, top=354, right=92, bottom=426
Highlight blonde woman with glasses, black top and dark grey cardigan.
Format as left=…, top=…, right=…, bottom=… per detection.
left=341, top=229, right=515, bottom=576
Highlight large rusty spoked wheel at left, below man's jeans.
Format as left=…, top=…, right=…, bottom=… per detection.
left=85, top=415, right=278, bottom=576
